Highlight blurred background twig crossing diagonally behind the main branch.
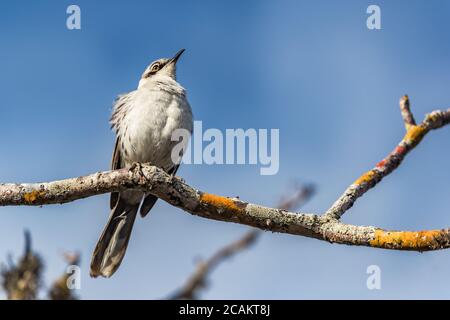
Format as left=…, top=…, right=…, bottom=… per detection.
left=170, top=185, right=315, bottom=299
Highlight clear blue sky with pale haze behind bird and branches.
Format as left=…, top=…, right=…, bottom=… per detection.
left=0, top=0, right=450, bottom=299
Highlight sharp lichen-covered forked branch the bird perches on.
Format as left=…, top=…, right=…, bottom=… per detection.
left=0, top=99, right=450, bottom=251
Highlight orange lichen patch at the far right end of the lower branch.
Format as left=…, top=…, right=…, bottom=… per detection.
left=370, top=229, right=443, bottom=249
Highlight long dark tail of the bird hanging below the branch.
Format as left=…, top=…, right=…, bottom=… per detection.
left=90, top=199, right=139, bottom=278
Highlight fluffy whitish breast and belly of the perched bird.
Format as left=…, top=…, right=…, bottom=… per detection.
left=112, top=79, right=192, bottom=170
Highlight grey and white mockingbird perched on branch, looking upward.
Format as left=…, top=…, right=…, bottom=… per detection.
left=90, top=49, right=192, bottom=277
